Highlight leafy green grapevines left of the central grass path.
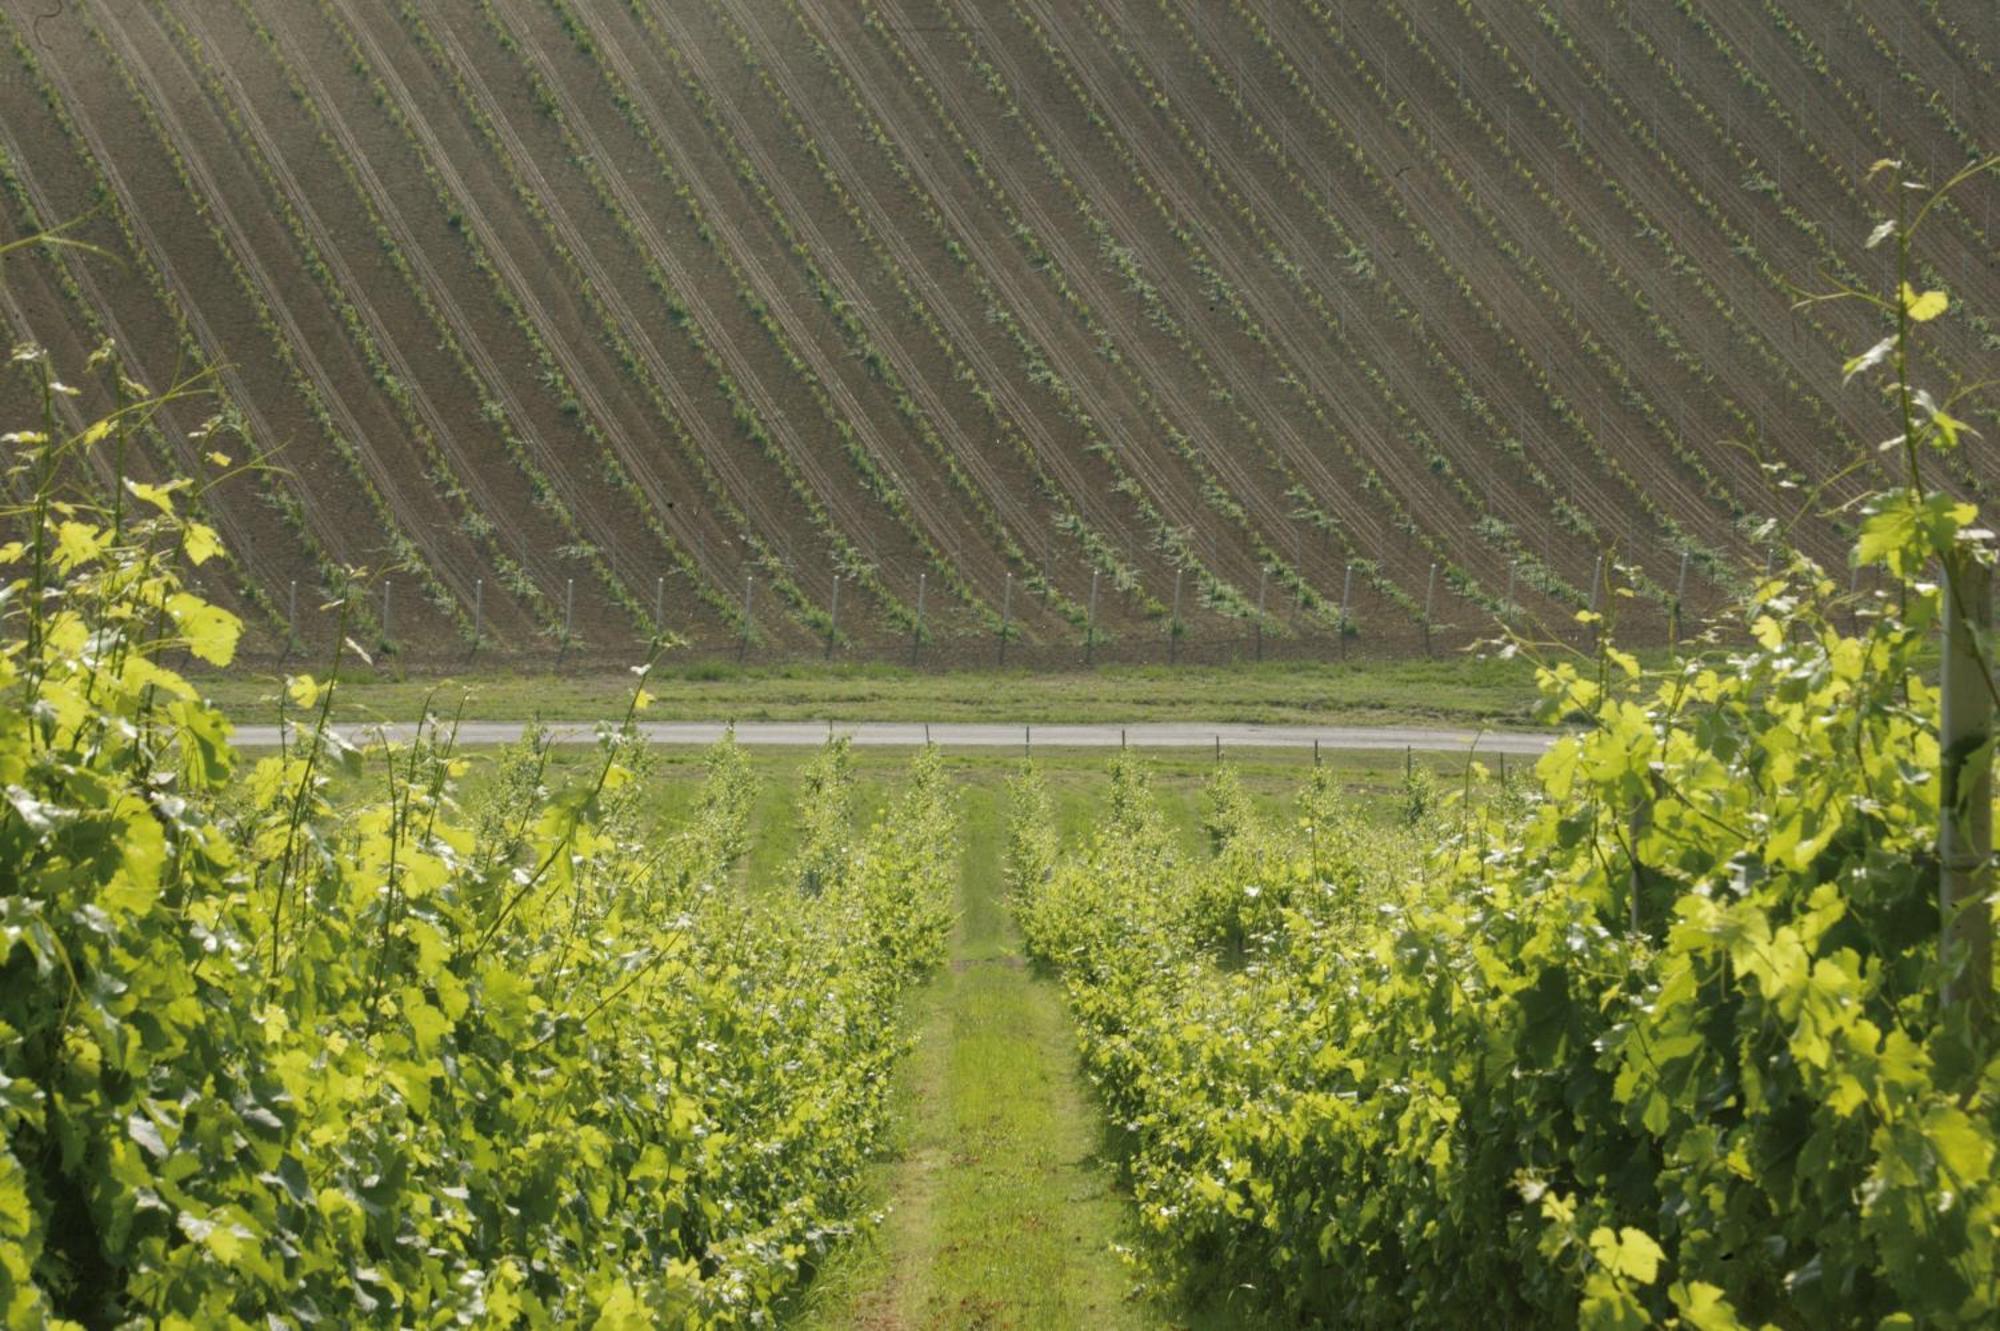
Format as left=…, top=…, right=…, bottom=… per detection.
left=0, top=349, right=954, bottom=1327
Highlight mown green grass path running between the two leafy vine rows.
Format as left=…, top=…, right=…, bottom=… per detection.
left=796, top=773, right=1188, bottom=1331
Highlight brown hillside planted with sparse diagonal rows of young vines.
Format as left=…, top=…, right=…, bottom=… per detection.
left=0, top=0, right=2000, bottom=662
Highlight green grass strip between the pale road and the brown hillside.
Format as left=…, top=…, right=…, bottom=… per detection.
left=196, top=658, right=1534, bottom=725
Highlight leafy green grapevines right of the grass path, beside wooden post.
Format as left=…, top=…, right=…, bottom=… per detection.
left=1016, top=178, right=2000, bottom=1331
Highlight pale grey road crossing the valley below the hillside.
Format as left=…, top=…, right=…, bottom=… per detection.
left=236, top=721, right=1554, bottom=757
